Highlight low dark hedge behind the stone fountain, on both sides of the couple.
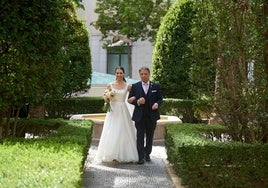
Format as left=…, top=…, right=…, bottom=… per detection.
left=45, top=97, right=197, bottom=123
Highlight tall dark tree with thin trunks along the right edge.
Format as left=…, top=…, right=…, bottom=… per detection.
left=192, top=0, right=268, bottom=143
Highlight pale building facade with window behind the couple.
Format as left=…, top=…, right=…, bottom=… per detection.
left=77, top=0, right=153, bottom=79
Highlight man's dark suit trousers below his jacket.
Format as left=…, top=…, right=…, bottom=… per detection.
left=135, top=116, right=156, bottom=159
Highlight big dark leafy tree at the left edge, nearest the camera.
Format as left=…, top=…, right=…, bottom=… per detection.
left=0, top=0, right=90, bottom=138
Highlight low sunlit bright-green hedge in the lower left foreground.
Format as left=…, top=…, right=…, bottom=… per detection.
left=0, top=119, right=93, bottom=188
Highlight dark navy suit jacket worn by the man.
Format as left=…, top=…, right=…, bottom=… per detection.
left=128, top=81, right=163, bottom=122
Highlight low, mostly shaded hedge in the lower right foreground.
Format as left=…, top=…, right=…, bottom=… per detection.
left=165, top=124, right=268, bottom=187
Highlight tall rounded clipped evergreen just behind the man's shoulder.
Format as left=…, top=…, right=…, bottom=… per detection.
left=152, top=1, right=195, bottom=99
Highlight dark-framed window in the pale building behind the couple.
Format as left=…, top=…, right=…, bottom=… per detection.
left=107, top=46, right=129, bottom=77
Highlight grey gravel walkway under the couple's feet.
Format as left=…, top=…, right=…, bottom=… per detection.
left=82, top=140, right=182, bottom=188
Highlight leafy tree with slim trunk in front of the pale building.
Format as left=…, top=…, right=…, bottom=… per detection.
left=92, top=0, right=171, bottom=76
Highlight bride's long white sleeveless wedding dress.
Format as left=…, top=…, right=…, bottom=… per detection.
left=95, top=84, right=138, bottom=163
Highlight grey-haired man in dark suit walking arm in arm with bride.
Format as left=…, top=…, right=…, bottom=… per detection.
left=128, top=67, right=163, bottom=164
